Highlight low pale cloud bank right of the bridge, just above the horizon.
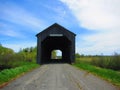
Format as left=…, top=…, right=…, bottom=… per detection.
left=76, top=32, right=120, bottom=55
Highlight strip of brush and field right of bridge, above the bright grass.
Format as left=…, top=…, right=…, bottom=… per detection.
left=76, top=53, right=120, bottom=70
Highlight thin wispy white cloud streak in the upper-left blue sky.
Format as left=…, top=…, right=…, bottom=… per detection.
left=0, top=4, right=45, bottom=32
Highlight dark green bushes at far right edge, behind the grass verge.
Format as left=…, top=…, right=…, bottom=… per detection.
left=91, top=53, right=120, bottom=70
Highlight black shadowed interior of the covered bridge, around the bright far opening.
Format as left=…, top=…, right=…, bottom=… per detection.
left=41, top=36, right=71, bottom=64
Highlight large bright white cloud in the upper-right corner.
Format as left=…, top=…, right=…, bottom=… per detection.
left=60, top=0, right=120, bottom=30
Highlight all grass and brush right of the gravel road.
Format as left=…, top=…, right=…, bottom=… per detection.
left=73, top=53, right=120, bottom=86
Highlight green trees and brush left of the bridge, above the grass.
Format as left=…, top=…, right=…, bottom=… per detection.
left=0, top=45, right=37, bottom=70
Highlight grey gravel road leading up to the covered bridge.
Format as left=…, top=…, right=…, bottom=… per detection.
left=0, top=64, right=118, bottom=90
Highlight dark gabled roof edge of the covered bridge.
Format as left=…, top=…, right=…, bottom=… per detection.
left=36, top=23, right=76, bottom=36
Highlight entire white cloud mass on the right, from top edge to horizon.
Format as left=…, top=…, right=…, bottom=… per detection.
left=60, top=0, right=120, bottom=54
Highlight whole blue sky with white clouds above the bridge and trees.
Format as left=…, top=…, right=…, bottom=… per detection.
left=0, top=0, right=120, bottom=55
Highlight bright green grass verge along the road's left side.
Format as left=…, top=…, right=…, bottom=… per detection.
left=0, top=63, right=39, bottom=85
